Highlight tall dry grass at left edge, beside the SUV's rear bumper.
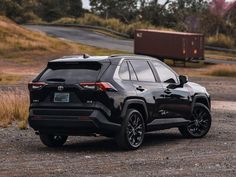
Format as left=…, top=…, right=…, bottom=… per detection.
left=0, top=89, right=29, bottom=129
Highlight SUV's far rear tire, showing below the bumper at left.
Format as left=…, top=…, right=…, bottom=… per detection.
left=39, top=133, right=68, bottom=147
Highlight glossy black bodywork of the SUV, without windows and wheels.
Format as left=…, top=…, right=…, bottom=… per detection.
left=29, top=55, right=210, bottom=135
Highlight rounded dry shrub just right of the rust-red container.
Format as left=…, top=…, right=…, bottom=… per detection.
left=206, top=34, right=234, bottom=48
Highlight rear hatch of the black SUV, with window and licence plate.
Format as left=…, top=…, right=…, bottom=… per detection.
left=29, top=61, right=110, bottom=110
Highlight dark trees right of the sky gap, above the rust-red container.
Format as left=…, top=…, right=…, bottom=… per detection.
left=90, top=0, right=236, bottom=35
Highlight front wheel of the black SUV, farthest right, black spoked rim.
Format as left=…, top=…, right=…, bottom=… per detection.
left=179, top=103, right=211, bottom=138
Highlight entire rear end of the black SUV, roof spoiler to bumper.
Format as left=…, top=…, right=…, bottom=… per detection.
left=29, top=57, right=120, bottom=135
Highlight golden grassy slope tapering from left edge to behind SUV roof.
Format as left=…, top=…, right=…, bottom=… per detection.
left=0, top=16, right=120, bottom=64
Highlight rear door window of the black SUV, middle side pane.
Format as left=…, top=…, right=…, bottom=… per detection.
left=130, top=60, right=155, bottom=82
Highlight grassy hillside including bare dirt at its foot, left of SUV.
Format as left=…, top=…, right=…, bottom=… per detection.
left=0, top=16, right=119, bottom=85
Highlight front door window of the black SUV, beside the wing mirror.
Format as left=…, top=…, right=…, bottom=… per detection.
left=152, top=61, right=178, bottom=83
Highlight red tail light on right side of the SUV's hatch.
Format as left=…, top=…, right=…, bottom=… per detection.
left=80, top=82, right=117, bottom=92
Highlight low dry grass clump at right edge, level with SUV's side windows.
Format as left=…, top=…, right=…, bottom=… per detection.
left=205, top=65, right=236, bottom=77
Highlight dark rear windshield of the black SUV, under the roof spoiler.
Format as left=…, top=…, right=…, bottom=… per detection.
left=39, top=62, right=102, bottom=84
